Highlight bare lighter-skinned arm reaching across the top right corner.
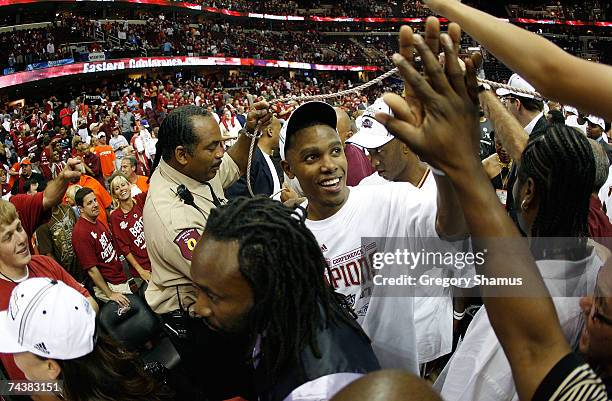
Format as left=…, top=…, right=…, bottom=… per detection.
left=424, top=0, right=612, bottom=120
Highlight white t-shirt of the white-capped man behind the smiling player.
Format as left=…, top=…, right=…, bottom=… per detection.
left=359, top=171, right=453, bottom=364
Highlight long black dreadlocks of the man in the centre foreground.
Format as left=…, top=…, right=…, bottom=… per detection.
left=204, top=196, right=365, bottom=378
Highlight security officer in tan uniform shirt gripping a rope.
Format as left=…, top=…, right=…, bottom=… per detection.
left=143, top=102, right=271, bottom=400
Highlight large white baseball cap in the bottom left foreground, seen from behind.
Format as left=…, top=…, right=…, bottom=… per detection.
left=0, top=277, right=96, bottom=360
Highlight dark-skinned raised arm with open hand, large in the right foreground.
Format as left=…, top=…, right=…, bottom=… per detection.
left=376, top=23, right=570, bottom=400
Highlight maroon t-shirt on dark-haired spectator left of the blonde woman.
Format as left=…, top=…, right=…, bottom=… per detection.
left=72, top=217, right=127, bottom=284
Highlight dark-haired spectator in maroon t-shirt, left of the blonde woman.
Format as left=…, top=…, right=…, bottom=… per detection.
left=72, top=188, right=132, bottom=306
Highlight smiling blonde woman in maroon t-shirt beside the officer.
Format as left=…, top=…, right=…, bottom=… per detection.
left=110, top=174, right=151, bottom=282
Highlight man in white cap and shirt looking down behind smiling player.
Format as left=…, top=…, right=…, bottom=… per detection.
left=349, top=106, right=464, bottom=365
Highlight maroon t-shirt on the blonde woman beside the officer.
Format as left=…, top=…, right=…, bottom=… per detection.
left=111, top=192, right=151, bottom=277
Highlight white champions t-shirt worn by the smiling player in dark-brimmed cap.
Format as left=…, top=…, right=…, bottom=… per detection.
left=306, top=183, right=466, bottom=374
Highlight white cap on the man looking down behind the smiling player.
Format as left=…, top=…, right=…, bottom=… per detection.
left=346, top=98, right=394, bottom=149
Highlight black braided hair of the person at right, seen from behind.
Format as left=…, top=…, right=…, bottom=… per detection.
left=518, top=124, right=595, bottom=238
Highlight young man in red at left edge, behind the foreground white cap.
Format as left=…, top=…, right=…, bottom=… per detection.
left=0, top=200, right=98, bottom=380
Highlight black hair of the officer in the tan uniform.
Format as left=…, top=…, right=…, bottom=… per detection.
left=151, top=105, right=211, bottom=174
